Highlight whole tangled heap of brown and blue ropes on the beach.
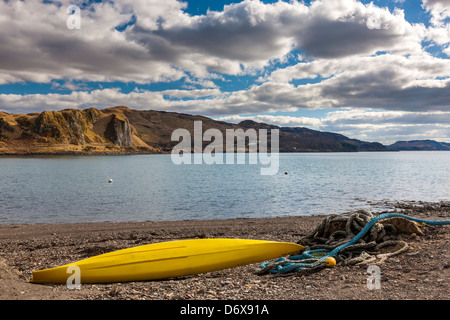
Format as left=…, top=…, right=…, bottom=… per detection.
left=257, top=210, right=450, bottom=275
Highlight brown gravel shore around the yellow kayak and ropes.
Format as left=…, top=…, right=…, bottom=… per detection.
left=0, top=202, right=450, bottom=300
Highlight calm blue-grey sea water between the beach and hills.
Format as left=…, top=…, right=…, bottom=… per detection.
left=0, top=152, right=450, bottom=224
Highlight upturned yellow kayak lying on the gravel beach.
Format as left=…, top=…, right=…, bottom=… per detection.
left=31, top=239, right=303, bottom=283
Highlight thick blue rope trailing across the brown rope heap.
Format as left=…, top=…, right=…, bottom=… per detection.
left=261, top=213, right=450, bottom=273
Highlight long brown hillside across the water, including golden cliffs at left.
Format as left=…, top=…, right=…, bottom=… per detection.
left=0, top=106, right=386, bottom=155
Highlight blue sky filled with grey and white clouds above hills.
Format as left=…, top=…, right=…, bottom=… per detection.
left=0, top=0, right=450, bottom=144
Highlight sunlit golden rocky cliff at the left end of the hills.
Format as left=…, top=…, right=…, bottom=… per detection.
left=0, top=108, right=153, bottom=154
